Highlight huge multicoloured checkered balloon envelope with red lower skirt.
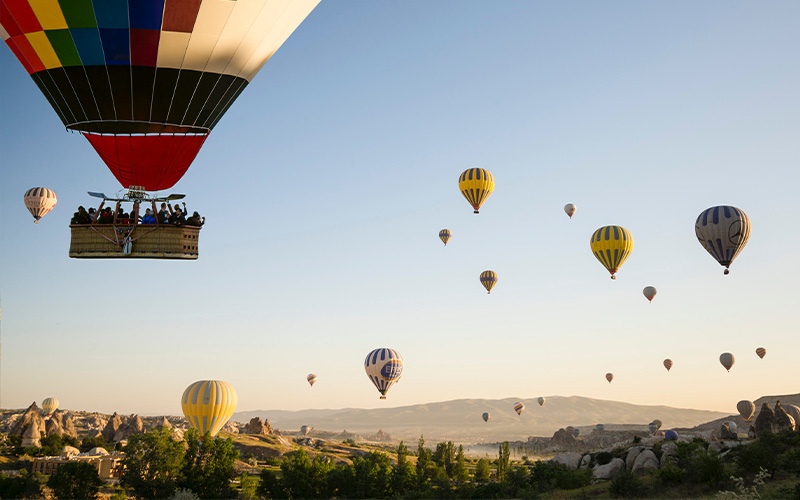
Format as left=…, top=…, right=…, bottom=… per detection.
left=0, top=0, right=319, bottom=191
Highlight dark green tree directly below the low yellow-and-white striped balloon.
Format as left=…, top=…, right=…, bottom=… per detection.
left=178, top=429, right=239, bottom=499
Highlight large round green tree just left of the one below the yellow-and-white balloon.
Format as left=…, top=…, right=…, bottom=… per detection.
left=120, top=429, right=184, bottom=498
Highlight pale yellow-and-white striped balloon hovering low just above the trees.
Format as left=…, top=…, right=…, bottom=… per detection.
left=181, top=380, right=238, bottom=437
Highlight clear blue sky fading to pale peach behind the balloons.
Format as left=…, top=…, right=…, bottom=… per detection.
left=0, top=0, right=800, bottom=415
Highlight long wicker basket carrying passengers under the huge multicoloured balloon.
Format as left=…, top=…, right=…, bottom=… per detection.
left=69, top=224, right=200, bottom=260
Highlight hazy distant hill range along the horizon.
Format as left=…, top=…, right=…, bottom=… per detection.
left=232, top=396, right=726, bottom=443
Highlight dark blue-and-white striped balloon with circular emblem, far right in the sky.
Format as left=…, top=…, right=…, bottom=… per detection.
left=694, top=205, right=752, bottom=274
